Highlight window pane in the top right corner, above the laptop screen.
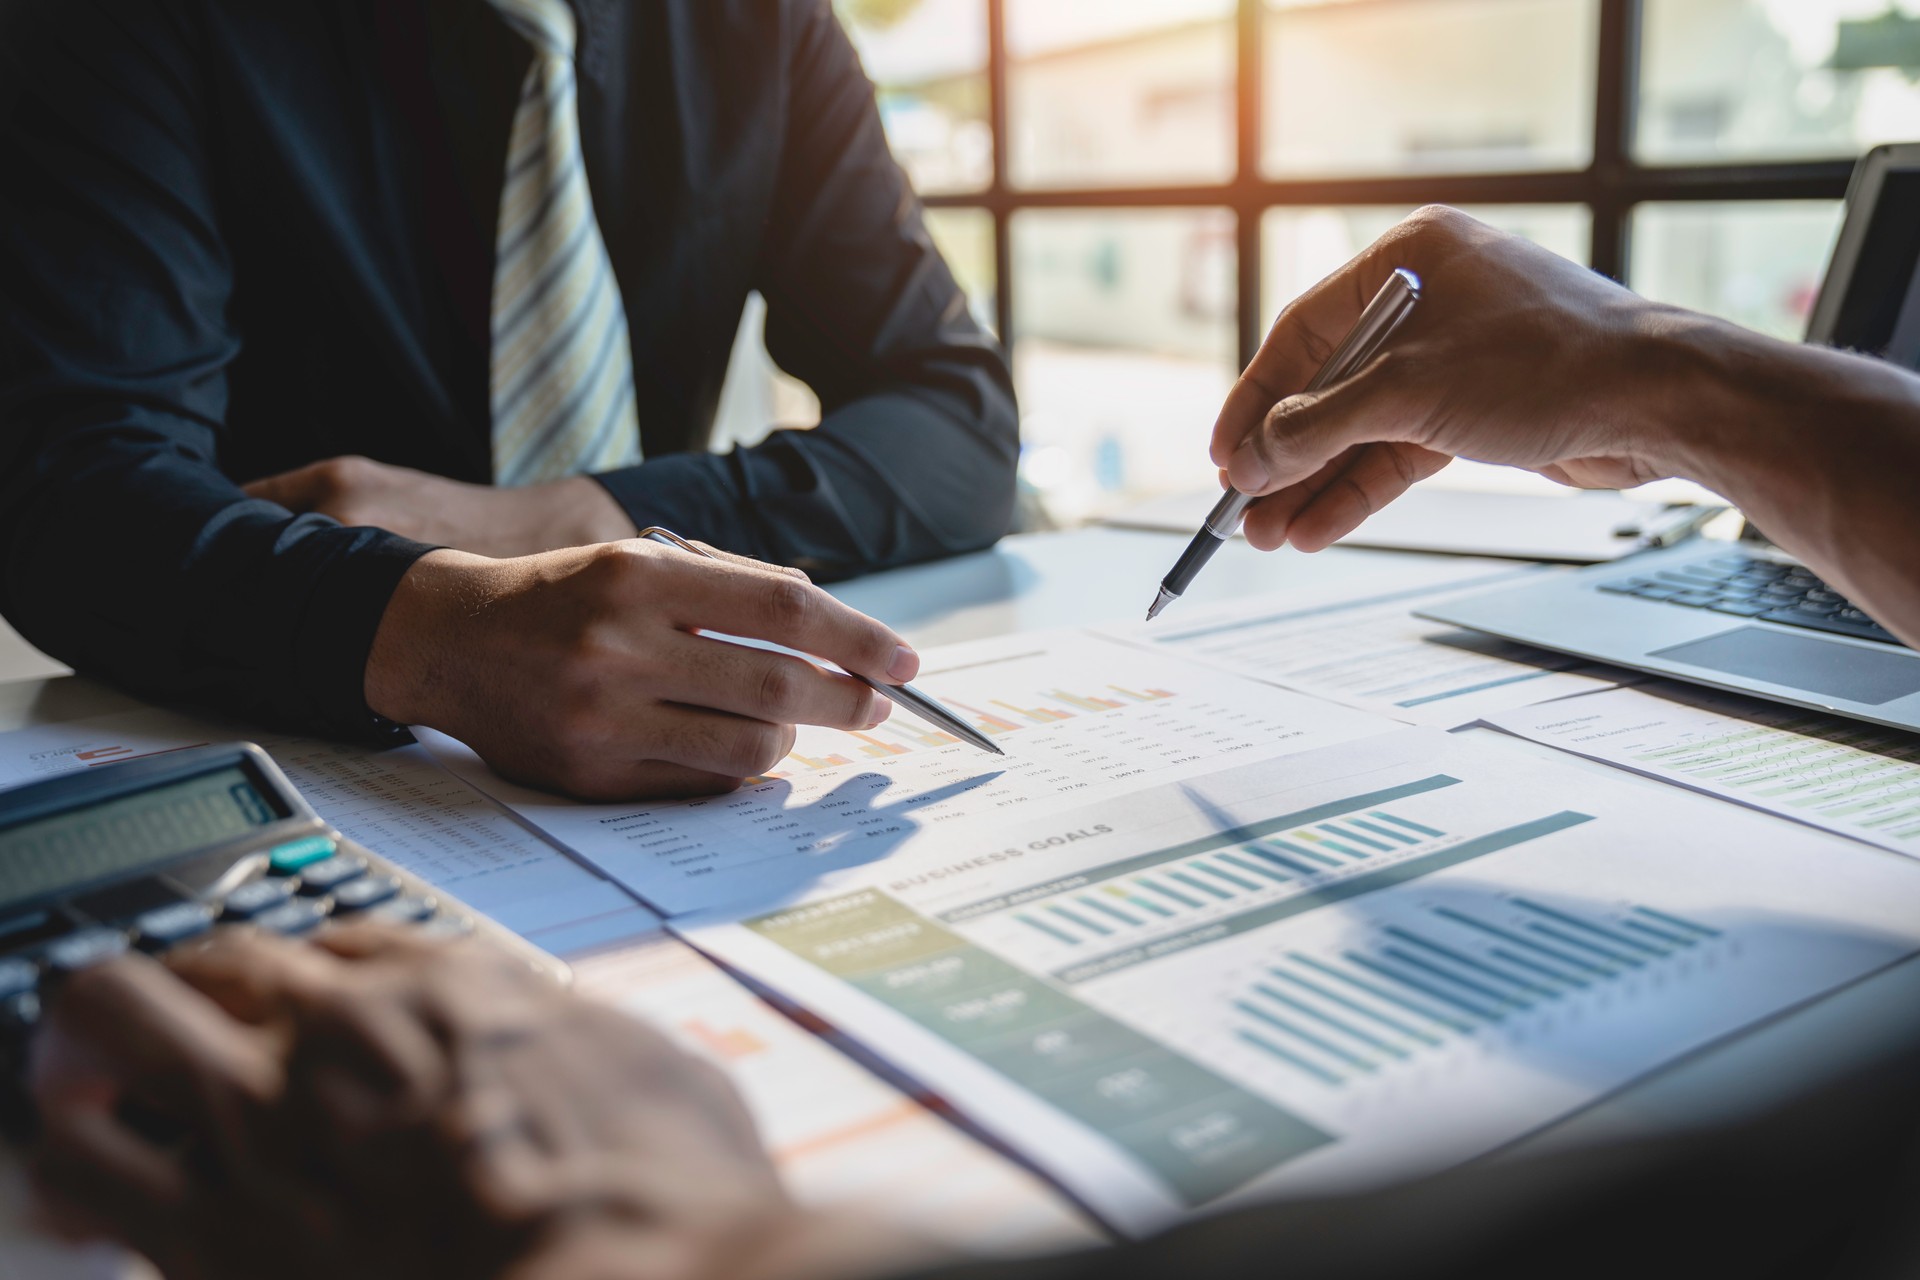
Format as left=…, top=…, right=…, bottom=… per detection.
left=1638, top=0, right=1920, bottom=163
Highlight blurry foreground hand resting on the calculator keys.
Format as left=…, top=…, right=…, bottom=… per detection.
left=33, top=925, right=936, bottom=1280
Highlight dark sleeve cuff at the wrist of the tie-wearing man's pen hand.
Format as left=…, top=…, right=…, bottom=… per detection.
left=294, top=528, right=440, bottom=747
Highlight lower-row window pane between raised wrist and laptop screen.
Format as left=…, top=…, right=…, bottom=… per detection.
left=1628, top=200, right=1841, bottom=342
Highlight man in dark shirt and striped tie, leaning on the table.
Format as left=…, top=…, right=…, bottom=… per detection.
left=0, top=0, right=1018, bottom=796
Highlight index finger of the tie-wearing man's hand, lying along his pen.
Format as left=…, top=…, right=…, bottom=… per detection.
left=628, top=543, right=920, bottom=683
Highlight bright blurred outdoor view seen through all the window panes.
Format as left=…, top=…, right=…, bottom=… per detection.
left=722, top=0, right=1920, bottom=522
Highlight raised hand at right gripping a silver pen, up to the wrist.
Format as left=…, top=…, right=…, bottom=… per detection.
left=1213, top=207, right=1693, bottom=551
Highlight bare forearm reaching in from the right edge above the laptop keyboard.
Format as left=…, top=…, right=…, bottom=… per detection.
left=1657, top=315, right=1920, bottom=645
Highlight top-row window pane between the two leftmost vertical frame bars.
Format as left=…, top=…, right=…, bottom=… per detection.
left=1006, top=0, right=1235, bottom=186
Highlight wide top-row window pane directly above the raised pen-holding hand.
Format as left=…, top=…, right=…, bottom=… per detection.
left=1261, top=0, right=1599, bottom=177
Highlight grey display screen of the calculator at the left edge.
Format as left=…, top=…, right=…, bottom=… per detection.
left=0, top=766, right=286, bottom=906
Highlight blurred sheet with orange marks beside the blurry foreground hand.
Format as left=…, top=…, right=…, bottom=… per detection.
left=574, top=936, right=1100, bottom=1253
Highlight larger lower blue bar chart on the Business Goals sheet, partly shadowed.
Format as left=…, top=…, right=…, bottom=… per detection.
left=1229, top=898, right=1720, bottom=1088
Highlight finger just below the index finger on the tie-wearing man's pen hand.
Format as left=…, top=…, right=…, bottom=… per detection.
left=648, top=635, right=893, bottom=729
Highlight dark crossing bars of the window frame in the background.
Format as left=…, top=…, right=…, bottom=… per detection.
left=922, top=0, right=1853, bottom=367
